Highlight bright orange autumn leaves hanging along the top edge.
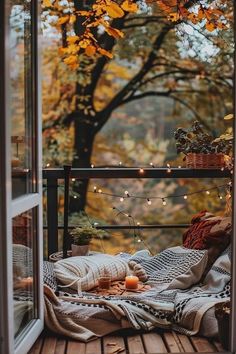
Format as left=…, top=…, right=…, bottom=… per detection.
left=42, top=0, right=230, bottom=70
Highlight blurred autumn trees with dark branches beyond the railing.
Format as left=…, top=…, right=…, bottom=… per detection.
left=43, top=1, right=233, bottom=254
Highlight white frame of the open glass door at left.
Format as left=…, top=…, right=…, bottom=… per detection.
left=0, top=0, right=44, bottom=354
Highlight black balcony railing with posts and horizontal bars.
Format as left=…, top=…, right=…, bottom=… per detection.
left=43, top=167, right=231, bottom=255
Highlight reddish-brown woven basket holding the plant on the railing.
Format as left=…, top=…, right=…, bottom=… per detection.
left=185, top=153, right=225, bottom=169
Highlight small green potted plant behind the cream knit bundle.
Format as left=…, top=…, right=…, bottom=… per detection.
left=70, top=225, right=105, bottom=256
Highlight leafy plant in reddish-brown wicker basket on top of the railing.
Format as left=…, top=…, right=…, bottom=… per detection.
left=174, top=121, right=233, bottom=168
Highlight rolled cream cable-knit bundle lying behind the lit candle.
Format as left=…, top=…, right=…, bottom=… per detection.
left=54, top=253, right=129, bottom=292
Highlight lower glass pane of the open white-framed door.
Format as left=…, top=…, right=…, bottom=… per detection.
left=13, top=209, right=37, bottom=337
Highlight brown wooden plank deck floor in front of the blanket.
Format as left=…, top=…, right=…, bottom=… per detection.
left=28, top=331, right=225, bottom=354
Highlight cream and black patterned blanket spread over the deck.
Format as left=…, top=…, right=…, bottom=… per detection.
left=42, top=248, right=230, bottom=341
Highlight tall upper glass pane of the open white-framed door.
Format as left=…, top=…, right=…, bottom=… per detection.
left=9, top=0, right=34, bottom=198
